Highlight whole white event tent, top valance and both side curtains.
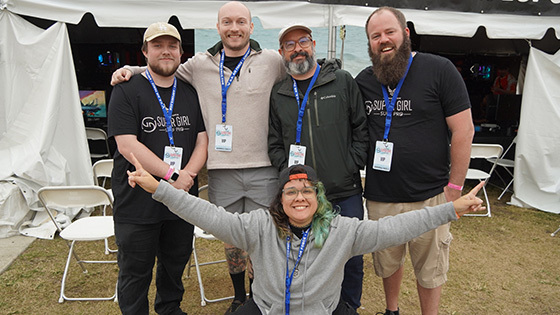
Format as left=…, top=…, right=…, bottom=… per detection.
left=0, top=0, right=560, bottom=237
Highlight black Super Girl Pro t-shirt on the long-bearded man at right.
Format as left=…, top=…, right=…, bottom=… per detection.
left=356, top=53, right=470, bottom=202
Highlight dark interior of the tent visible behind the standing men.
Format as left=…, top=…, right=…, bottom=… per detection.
left=21, top=13, right=560, bottom=157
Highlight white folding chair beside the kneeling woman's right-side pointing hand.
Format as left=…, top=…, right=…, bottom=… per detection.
left=465, top=143, right=503, bottom=217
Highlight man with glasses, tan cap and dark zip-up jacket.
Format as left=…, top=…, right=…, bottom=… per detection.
left=268, top=24, right=368, bottom=309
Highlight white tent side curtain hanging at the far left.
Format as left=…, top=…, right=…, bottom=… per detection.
left=0, top=10, right=93, bottom=237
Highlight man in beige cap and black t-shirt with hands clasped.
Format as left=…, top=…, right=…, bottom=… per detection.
left=108, top=22, right=208, bottom=315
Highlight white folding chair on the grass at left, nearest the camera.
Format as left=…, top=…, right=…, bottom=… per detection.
left=37, top=186, right=117, bottom=303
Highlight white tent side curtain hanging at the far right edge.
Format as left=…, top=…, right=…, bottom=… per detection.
left=511, top=48, right=560, bottom=213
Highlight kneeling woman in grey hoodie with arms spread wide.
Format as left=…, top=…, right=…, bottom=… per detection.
left=129, top=157, right=484, bottom=315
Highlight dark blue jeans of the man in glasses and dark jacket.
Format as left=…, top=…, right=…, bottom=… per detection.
left=331, top=194, right=364, bottom=309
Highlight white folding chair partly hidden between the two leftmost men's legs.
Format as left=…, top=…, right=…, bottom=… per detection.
left=187, top=185, right=233, bottom=306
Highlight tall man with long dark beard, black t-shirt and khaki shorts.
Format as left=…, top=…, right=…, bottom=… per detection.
left=356, top=7, right=474, bottom=315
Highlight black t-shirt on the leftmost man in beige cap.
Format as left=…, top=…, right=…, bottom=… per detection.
left=108, top=75, right=205, bottom=224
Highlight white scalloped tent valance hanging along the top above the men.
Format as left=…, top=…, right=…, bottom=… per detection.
left=6, top=0, right=560, bottom=39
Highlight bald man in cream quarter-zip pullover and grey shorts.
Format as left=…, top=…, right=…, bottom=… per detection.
left=111, top=1, right=286, bottom=314
